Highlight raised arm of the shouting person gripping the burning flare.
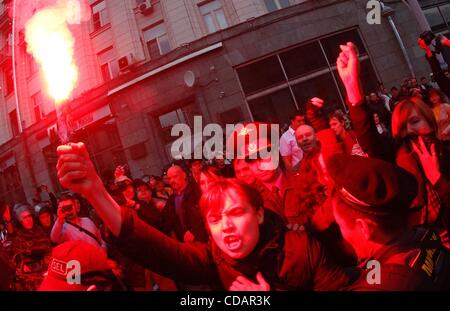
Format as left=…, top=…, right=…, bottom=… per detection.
left=57, top=143, right=215, bottom=283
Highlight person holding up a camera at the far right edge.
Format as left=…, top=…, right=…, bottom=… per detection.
left=418, top=31, right=450, bottom=96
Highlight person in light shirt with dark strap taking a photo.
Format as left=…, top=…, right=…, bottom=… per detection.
left=50, top=194, right=104, bottom=251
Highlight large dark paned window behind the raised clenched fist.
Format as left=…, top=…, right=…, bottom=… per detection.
left=236, top=29, right=378, bottom=125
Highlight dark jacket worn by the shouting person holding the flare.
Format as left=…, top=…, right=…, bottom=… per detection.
left=111, top=209, right=349, bottom=290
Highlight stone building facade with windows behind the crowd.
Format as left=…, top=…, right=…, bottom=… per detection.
left=0, top=0, right=450, bottom=202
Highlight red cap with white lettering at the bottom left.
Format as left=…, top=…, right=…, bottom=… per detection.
left=38, top=240, right=114, bottom=291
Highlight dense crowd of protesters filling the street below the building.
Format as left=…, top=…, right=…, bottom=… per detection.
left=0, top=34, right=450, bottom=290
